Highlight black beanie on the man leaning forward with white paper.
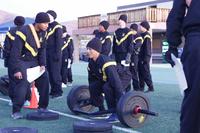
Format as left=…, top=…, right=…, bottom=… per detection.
left=35, top=12, right=50, bottom=23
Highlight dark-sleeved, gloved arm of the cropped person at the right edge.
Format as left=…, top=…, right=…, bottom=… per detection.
left=165, top=0, right=187, bottom=67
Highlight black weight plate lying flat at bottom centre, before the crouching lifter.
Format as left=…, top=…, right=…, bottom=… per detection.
left=73, top=121, right=112, bottom=133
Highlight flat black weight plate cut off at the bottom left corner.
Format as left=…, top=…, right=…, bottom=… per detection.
left=0, top=127, right=38, bottom=133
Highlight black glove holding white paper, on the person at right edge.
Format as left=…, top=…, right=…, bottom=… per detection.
left=165, top=47, right=178, bottom=67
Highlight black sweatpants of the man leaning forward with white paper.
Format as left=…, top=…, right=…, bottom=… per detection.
left=12, top=62, right=49, bottom=113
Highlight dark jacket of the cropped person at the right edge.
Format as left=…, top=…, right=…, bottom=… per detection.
left=167, top=0, right=200, bottom=47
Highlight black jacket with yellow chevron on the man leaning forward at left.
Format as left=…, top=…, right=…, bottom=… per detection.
left=10, top=25, right=46, bottom=72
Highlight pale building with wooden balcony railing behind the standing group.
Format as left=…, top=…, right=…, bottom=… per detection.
left=73, top=0, right=173, bottom=62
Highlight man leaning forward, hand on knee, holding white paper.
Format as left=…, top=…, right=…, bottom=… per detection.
left=9, top=12, right=50, bottom=119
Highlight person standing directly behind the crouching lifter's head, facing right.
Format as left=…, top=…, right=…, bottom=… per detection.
left=95, top=20, right=112, bottom=55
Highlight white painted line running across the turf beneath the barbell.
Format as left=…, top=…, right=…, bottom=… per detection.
left=0, top=98, right=141, bottom=133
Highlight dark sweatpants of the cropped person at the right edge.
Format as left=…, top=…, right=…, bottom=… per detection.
left=180, top=32, right=200, bottom=133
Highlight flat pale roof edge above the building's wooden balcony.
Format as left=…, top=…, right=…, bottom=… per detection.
left=117, top=0, right=173, bottom=10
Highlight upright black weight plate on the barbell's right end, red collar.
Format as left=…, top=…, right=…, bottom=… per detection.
left=117, top=91, right=150, bottom=128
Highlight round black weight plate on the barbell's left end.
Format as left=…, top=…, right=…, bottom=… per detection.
left=67, top=85, right=95, bottom=114
